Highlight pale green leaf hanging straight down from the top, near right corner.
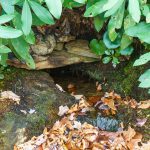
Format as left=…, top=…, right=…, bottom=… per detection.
left=128, top=0, right=141, bottom=23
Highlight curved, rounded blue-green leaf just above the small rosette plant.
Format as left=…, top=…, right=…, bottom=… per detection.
left=103, top=32, right=121, bottom=49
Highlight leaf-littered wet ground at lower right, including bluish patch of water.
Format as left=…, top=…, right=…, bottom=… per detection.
left=14, top=77, right=150, bottom=150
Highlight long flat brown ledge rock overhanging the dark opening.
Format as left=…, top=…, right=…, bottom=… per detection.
left=7, top=50, right=99, bottom=70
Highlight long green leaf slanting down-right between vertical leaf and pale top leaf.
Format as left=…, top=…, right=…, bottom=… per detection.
left=29, top=1, right=54, bottom=24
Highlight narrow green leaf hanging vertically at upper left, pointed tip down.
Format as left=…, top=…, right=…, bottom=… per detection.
left=21, top=0, right=32, bottom=35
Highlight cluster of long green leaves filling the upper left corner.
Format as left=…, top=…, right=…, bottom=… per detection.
left=0, top=0, right=56, bottom=69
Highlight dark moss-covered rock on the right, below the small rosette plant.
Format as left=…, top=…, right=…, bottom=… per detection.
left=71, top=60, right=150, bottom=100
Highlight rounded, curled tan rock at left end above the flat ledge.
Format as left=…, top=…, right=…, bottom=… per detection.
left=31, top=35, right=56, bottom=56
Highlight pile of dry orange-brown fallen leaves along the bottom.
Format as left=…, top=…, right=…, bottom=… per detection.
left=14, top=92, right=150, bottom=150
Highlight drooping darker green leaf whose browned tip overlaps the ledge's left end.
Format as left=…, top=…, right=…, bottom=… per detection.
left=11, top=37, right=35, bottom=69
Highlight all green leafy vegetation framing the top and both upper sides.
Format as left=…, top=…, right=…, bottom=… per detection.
left=0, top=0, right=150, bottom=92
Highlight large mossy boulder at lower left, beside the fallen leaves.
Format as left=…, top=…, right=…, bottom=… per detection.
left=0, top=69, right=75, bottom=150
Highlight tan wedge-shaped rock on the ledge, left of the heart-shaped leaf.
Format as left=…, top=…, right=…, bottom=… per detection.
left=65, top=40, right=99, bottom=58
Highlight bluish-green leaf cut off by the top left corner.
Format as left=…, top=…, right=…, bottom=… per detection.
left=0, top=0, right=14, bottom=14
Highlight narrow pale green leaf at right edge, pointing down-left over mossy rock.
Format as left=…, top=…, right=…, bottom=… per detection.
left=133, top=52, right=150, bottom=66
